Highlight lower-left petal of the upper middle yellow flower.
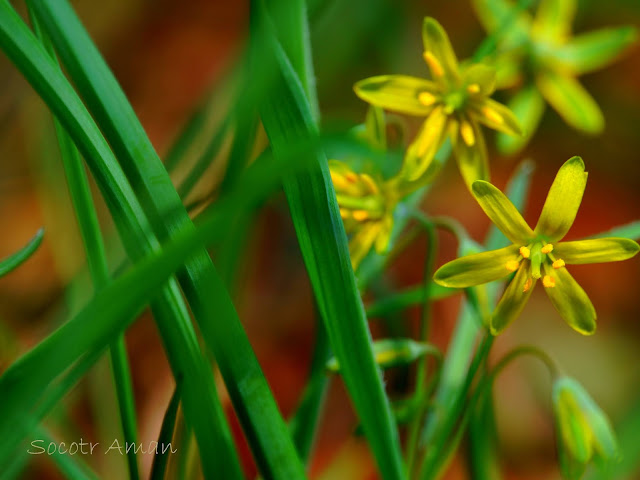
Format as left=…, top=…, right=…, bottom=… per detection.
left=401, top=106, right=448, bottom=181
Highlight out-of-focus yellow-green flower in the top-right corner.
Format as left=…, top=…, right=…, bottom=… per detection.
left=473, top=0, right=637, bottom=153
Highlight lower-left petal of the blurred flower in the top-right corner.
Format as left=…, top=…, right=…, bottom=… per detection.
left=496, top=85, right=545, bottom=155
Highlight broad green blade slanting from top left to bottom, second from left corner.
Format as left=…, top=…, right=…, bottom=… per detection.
left=30, top=0, right=303, bottom=478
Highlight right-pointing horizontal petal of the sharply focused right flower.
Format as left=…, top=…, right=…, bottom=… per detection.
left=553, top=238, right=640, bottom=265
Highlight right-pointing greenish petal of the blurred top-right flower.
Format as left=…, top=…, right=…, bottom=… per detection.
left=553, top=26, right=638, bottom=75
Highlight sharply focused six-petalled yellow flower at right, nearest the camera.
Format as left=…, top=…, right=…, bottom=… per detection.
left=434, top=157, right=640, bottom=335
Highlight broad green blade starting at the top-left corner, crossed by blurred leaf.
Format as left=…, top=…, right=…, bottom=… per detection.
left=0, top=5, right=241, bottom=477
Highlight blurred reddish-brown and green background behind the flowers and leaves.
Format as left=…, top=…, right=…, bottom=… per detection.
left=0, top=0, right=640, bottom=479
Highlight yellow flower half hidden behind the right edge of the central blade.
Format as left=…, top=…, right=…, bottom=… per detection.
left=329, top=160, right=398, bottom=270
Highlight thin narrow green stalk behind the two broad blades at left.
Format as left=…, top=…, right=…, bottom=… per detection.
left=29, top=8, right=140, bottom=480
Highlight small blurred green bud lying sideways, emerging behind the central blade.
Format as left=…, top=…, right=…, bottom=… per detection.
left=327, top=338, right=442, bottom=372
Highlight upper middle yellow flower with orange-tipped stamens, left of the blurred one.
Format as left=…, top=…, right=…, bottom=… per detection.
left=354, top=17, right=522, bottom=188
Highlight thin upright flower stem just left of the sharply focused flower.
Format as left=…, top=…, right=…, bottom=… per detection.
left=405, top=211, right=438, bottom=472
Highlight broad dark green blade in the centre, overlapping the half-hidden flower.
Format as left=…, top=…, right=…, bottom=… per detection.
left=253, top=5, right=404, bottom=479
